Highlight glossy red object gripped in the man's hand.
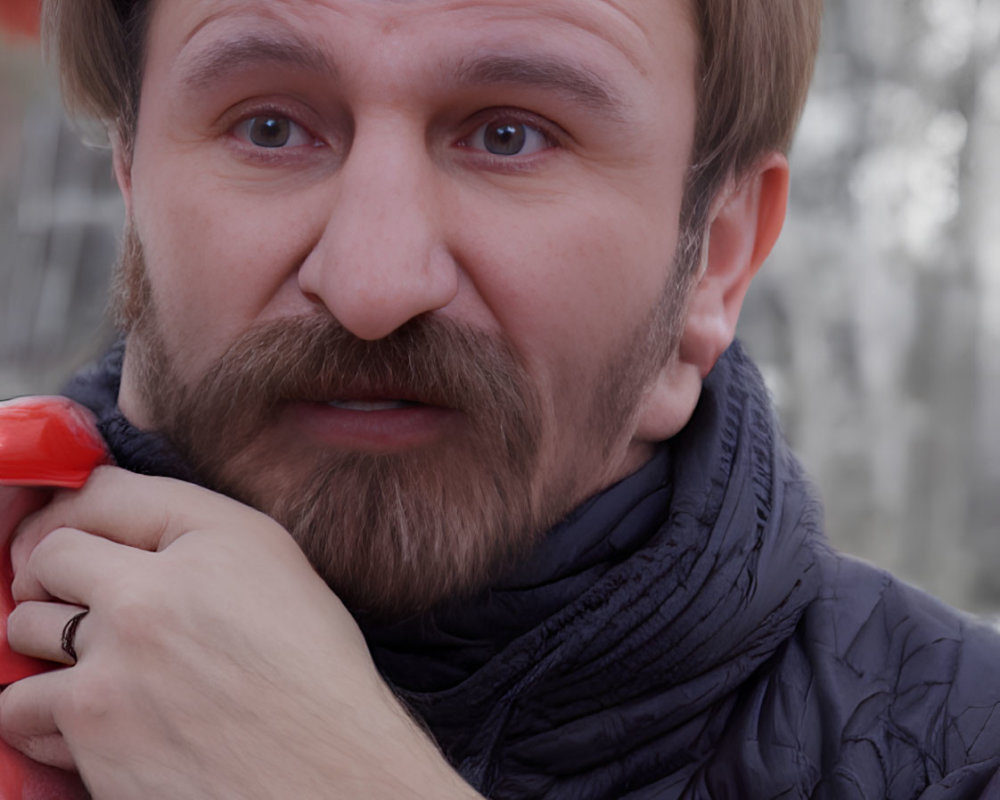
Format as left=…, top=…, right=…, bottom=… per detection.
left=0, top=396, right=111, bottom=800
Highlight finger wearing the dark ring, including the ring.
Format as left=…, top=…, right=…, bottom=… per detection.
left=7, top=601, right=87, bottom=666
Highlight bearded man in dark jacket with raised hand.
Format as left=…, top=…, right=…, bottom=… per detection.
left=0, top=0, right=1000, bottom=798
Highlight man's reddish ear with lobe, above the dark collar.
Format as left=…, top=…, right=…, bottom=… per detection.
left=635, top=153, right=788, bottom=442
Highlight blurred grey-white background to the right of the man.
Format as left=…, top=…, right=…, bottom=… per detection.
left=741, top=0, right=1000, bottom=609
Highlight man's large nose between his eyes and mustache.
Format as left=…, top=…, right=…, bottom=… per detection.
left=298, top=124, right=458, bottom=340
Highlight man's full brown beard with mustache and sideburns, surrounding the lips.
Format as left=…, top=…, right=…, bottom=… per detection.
left=113, top=224, right=686, bottom=621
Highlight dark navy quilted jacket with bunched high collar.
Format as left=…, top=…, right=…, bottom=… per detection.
left=70, top=347, right=1000, bottom=800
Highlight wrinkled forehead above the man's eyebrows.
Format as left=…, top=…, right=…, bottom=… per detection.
left=147, top=0, right=698, bottom=98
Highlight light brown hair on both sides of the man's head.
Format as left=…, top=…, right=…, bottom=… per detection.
left=43, top=0, right=823, bottom=272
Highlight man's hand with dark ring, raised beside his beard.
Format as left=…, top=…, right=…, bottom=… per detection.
left=0, top=467, right=475, bottom=800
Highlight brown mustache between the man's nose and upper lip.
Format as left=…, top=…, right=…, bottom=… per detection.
left=159, top=315, right=538, bottom=462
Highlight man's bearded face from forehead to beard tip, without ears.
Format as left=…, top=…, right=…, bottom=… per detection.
left=115, top=0, right=697, bottom=613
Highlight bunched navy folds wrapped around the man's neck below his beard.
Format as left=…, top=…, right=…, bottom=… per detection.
left=365, top=346, right=821, bottom=800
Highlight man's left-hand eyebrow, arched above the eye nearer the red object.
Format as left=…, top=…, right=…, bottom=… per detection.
left=181, top=33, right=337, bottom=90
